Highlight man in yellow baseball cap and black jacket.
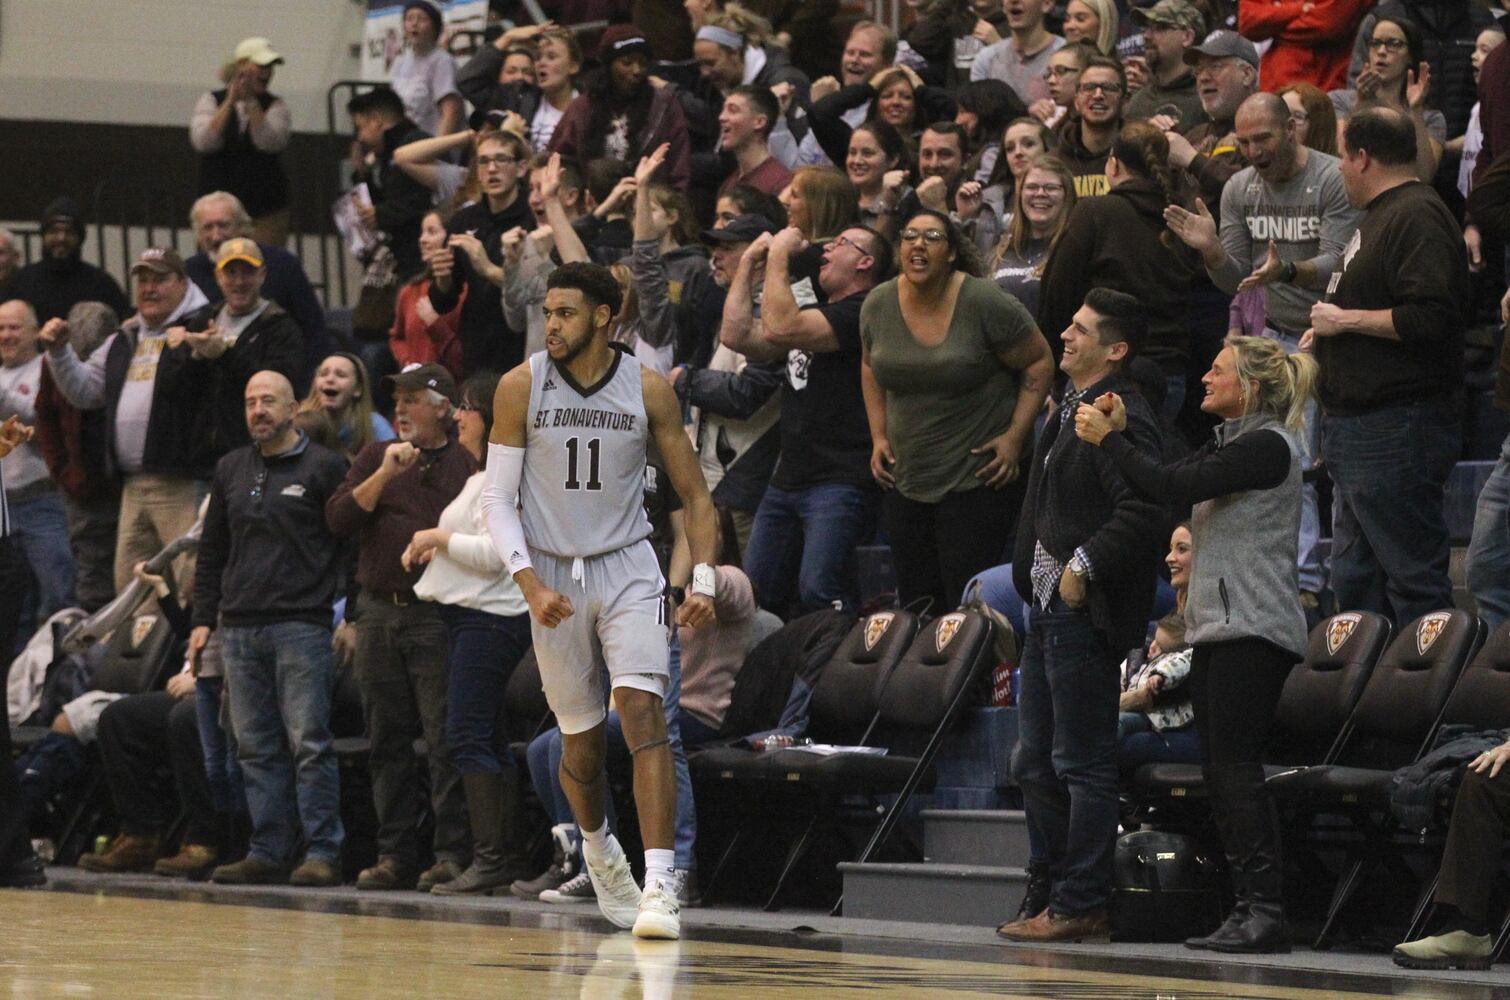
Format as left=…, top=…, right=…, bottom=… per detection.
left=168, top=236, right=304, bottom=462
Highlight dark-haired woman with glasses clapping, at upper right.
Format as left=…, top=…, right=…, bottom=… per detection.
left=1327, top=17, right=1447, bottom=183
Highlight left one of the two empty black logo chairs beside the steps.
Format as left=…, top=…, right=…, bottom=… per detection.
left=687, top=610, right=918, bottom=908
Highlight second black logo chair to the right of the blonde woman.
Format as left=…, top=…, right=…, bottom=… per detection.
left=1268, top=610, right=1484, bottom=949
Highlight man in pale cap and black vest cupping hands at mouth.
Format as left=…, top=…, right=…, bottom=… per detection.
left=189, top=38, right=293, bottom=246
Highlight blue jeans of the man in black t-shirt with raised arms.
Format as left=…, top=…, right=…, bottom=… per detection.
left=744, top=483, right=877, bottom=615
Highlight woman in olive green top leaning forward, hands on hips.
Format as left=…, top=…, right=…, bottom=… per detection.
left=861, top=210, right=1054, bottom=612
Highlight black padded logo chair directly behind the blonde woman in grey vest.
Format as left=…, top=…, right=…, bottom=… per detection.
left=1136, top=612, right=1391, bottom=804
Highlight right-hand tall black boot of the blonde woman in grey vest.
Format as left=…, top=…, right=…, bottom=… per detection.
left=1206, top=763, right=1290, bottom=955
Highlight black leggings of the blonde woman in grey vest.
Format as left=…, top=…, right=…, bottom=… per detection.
left=1190, top=639, right=1296, bottom=767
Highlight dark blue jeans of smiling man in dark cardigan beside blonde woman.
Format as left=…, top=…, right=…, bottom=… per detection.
left=1012, top=598, right=1119, bottom=915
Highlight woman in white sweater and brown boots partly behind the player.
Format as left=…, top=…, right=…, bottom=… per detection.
left=402, top=373, right=535, bottom=896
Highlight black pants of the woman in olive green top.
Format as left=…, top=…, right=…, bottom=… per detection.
left=882, top=474, right=1027, bottom=615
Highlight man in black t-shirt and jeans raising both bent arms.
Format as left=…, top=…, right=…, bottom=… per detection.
left=725, top=225, right=891, bottom=615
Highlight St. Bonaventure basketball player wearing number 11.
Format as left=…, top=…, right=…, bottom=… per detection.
left=483, top=263, right=719, bottom=940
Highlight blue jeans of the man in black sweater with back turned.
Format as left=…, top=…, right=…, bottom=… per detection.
left=1321, top=399, right=1462, bottom=627
